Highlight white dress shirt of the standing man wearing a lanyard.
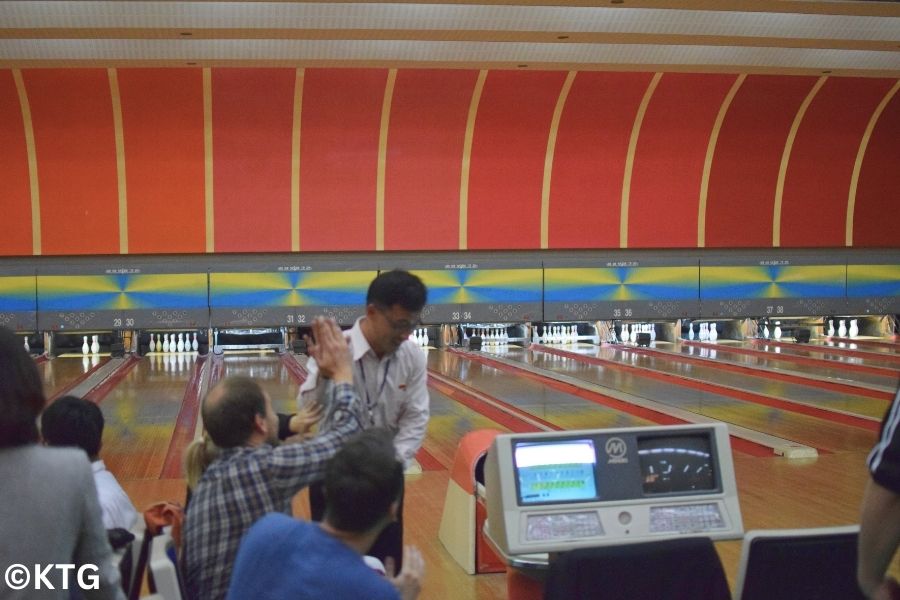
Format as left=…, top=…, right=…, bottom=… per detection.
left=298, top=317, right=429, bottom=467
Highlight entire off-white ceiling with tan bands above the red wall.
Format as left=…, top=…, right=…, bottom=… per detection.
left=0, top=0, right=900, bottom=77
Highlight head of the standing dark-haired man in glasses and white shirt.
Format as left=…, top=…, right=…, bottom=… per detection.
left=366, top=269, right=428, bottom=354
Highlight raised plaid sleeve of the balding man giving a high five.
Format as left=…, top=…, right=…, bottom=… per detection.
left=268, top=383, right=362, bottom=491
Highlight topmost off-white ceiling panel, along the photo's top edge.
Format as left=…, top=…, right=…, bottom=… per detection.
left=0, top=1, right=900, bottom=41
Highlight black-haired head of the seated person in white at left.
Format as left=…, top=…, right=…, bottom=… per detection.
left=41, top=396, right=103, bottom=460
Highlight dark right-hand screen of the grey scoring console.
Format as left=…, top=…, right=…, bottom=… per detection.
left=638, top=433, right=717, bottom=496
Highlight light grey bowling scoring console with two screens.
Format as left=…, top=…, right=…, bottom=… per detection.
left=485, top=423, right=743, bottom=555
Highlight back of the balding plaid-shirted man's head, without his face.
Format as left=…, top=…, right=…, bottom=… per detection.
left=202, top=377, right=266, bottom=448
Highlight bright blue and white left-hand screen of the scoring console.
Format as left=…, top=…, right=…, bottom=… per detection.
left=513, top=439, right=597, bottom=504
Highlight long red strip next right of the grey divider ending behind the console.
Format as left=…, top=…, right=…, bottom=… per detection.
left=529, top=344, right=881, bottom=433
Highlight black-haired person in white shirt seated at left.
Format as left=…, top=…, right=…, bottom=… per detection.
left=41, top=396, right=138, bottom=529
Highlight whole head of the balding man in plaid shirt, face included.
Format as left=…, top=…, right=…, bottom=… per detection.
left=202, top=377, right=278, bottom=448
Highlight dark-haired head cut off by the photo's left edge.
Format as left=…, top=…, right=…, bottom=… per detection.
left=0, top=327, right=46, bottom=448
